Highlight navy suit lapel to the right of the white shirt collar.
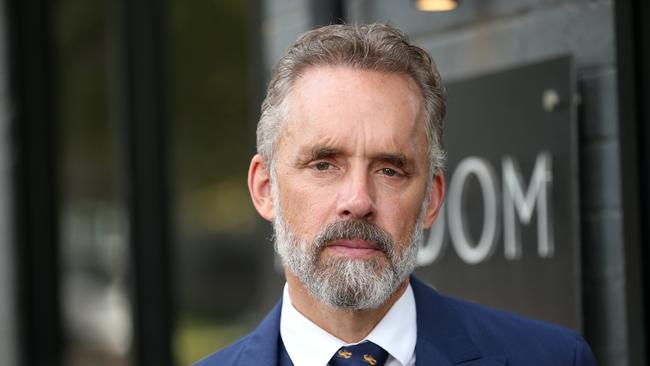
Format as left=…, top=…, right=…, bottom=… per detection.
left=411, top=276, right=506, bottom=366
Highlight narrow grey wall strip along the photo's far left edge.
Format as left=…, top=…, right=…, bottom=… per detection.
left=0, top=2, right=17, bottom=366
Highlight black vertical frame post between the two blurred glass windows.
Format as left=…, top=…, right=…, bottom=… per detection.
left=118, top=0, right=173, bottom=366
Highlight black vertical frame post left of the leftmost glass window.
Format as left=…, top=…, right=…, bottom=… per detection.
left=7, top=0, right=62, bottom=366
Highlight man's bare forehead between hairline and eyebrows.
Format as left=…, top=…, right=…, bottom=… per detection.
left=281, top=66, right=427, bottom=157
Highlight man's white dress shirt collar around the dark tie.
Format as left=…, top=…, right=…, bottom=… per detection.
left=280, top=284, right=417, bottom=366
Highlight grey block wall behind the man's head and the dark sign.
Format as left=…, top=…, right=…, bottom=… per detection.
left=262, top=0, right=629, bottom=366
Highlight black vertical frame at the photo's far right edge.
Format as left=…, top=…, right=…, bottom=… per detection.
left=615, top=0, right=650, bottom=365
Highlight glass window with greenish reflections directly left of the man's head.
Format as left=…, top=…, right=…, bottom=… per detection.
left=167, top=0, right=281, bottom=365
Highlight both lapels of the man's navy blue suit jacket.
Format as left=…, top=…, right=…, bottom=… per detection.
left=236, top=276, right=506, bottom=366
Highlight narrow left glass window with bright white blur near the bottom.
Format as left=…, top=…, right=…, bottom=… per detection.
left=53, top=0, right=131, bottom=366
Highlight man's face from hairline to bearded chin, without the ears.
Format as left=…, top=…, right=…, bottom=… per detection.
left=256, top=67, right=438, bottom=308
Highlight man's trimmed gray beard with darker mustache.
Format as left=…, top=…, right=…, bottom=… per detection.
left=273, top=189, right=426, bottom=310
